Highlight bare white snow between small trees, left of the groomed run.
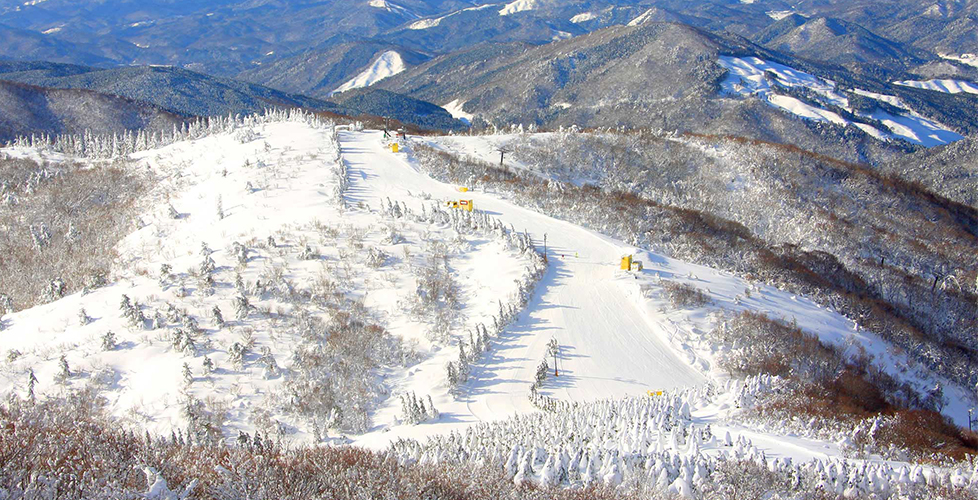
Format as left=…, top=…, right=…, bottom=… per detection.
left=0, top=118, right=526, bottom=441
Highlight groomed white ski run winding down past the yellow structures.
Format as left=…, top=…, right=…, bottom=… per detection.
left=340, top=132, right=706, bottom=443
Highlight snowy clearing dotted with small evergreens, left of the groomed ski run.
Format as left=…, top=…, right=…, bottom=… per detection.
left=0, top=117, right=527, bottom=441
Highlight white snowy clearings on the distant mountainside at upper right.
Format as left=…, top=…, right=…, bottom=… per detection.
left=720, top=56, right=960, bottom=147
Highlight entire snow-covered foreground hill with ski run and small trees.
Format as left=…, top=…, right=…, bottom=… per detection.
left=0, top=113, right=978, bottom=498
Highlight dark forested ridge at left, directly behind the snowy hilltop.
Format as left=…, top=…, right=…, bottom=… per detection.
left=0, top=61, right=464, bottom=140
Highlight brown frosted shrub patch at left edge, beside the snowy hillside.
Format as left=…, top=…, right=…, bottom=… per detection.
left=0, top=160, right=146, bottom=310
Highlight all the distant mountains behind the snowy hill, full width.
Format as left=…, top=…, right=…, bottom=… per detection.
left=0, top=0, right=978, bottom=156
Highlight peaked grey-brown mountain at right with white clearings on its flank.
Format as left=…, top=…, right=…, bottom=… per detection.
left=376, top=21, right=978, bottom=162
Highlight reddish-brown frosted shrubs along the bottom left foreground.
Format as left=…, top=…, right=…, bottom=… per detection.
left=0, top=393, right=629, bottom=500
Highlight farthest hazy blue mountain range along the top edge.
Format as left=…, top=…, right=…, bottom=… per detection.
left=0, top=0, right=978, bottom=88
